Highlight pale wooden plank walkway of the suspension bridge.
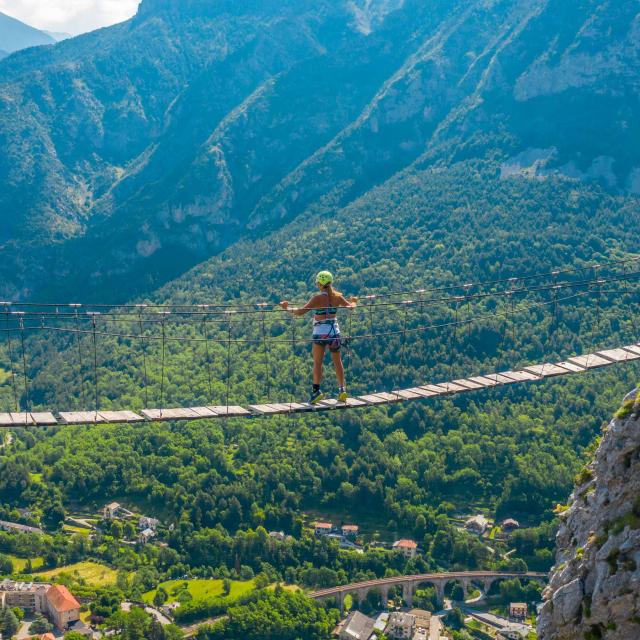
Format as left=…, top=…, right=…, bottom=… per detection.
left=0, top=343, right=640, bottom=429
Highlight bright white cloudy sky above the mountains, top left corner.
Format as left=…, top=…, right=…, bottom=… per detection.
left=0, top=0, right=140, bottom=35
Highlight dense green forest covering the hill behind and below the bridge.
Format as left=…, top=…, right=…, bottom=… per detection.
left=0, top=162, right=639, bottom=638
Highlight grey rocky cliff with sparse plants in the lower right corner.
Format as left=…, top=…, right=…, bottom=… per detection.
left=538, top=392, right=640, bottom=640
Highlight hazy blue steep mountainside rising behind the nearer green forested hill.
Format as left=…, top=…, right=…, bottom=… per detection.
left=0, top=0, right=640, bottom=300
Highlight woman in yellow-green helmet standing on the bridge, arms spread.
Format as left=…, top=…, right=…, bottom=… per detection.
left=280, top=271, right=358, bottom=404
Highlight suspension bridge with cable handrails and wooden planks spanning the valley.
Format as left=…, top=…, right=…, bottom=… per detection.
left=0, top=258, right=640, bottom=428
